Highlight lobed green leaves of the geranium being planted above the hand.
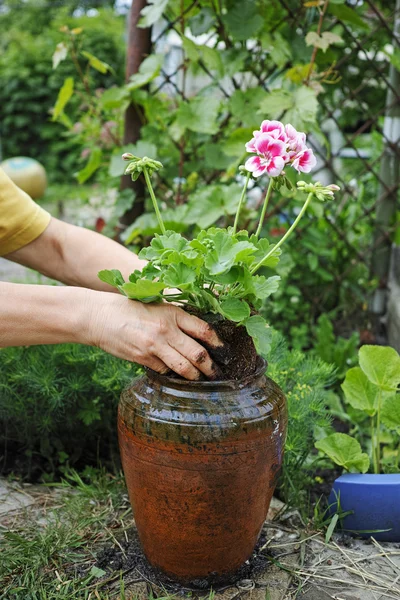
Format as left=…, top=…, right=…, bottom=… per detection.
left=99, top=227, right=279, bottom=356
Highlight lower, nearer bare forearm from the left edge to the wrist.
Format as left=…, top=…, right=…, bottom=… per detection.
left=0, top=282, right=91, bottom=348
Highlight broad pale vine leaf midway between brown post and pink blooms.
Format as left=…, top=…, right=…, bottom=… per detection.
left=176, top=96, right=221, bottom=135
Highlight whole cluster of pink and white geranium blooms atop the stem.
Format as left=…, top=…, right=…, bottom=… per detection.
left=245, top=120, right=317, bottom=177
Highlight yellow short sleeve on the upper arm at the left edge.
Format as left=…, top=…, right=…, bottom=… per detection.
left=0, top=168, right=51, bottom=256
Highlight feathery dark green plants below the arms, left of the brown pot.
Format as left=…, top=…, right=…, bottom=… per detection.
left=0, top=344, right=137, bottom=477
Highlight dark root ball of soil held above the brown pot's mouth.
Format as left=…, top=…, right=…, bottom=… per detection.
left=195, top=313, right=258, bottom=381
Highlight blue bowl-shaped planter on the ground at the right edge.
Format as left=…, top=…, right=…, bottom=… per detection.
left=329, top=473, right=400, bottom=542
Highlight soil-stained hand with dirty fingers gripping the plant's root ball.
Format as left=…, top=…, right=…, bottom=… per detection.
left=85, top=292, right=222, bottom=380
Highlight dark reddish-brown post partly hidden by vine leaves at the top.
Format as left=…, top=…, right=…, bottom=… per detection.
left=121, top=0, right=151, bottom=225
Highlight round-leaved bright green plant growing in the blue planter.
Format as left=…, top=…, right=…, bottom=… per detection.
left=316, top=346, right=400, bottom=473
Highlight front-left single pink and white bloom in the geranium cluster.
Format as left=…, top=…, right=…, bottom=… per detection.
left=245, top=133, right=287, bottom=177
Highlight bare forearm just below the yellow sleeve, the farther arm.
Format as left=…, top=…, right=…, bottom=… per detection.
left=6, top=219, right=146, bottom=292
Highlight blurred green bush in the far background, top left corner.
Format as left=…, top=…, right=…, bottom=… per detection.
left=0, top=0, right=124, bottom=180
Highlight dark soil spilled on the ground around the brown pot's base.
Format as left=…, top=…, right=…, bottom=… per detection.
left=95, top=529, right=271, bottom=594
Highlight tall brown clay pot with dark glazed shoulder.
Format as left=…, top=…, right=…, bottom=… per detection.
left=118, top=361, right=287, bottom=584
